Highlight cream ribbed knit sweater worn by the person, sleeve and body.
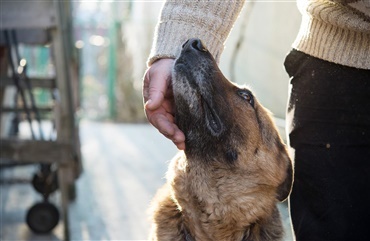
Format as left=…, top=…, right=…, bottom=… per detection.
left=148, top=0, right=370, bottom=69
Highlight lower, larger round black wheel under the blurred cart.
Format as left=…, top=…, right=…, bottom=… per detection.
left=26, top=202, right=59, bottom=234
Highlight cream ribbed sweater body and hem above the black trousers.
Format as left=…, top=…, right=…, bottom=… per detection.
left=293, top=0, right=370, bottom=69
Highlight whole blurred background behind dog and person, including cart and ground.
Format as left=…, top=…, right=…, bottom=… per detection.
left=0, top=0, right=300, bottom=241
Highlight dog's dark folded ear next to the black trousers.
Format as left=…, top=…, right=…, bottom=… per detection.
left=276, top=149, right=294, bottom=202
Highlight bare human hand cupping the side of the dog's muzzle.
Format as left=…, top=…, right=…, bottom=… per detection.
left=143, top=59, right=185, bottom=150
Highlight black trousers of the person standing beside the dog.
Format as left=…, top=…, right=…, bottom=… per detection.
left=284, top=50, right=370, bottom=241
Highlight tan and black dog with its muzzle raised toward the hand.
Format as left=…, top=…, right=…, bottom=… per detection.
left=150, top=39, right=293, bottom=241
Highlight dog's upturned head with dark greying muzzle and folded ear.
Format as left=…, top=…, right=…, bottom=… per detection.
left=172, top=39, right=292, bottom=200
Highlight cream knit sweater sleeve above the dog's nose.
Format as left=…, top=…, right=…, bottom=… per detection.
left=147, top=0, right=244, bottom=66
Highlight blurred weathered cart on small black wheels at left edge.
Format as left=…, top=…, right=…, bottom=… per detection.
left=0, top=0, right=82, bottom=240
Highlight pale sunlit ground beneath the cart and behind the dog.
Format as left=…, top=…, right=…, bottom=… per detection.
left=0, top=121, right=292, bottom=241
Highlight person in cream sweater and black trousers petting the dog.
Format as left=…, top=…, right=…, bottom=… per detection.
left=143, top=0, right=370, bottom=241
